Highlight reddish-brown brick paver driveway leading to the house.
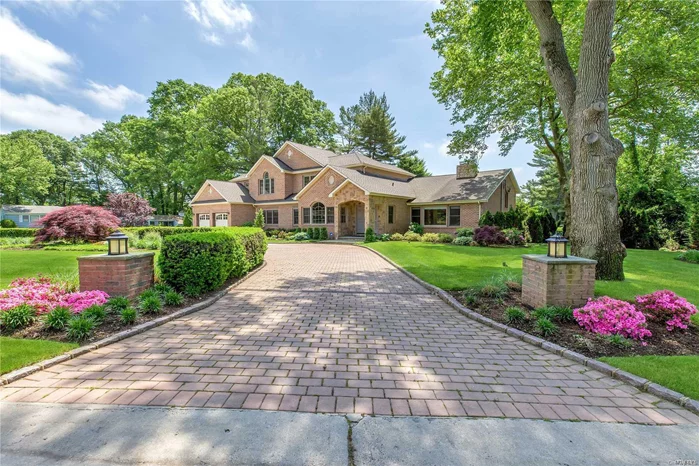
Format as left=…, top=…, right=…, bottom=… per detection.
left=0, top=244, right=699, bottom=424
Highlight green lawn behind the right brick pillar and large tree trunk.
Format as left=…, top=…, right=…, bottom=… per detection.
left=368, top=241, right=699, bottom=308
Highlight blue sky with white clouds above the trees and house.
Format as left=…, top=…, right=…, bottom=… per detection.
left=0, top=0, right=534, bottom=184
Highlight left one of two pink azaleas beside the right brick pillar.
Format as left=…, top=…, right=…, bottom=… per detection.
left=573, top=296, right=652, bottom=340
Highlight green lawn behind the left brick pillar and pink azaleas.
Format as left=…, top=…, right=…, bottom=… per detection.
left=0, top=250, right=104, bottom=288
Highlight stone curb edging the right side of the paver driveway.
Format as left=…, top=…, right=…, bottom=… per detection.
left=354, top=244, right=699, bottom=414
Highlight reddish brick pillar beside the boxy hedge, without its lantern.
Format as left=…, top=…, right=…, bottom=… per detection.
left=78, top=252, right=155, bottom=299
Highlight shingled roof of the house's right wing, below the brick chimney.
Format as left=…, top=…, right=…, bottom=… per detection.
left=408, top=168, right=519, bottom=204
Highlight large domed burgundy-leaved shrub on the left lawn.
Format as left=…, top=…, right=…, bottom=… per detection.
left=34, top=205, right=119, bottom=243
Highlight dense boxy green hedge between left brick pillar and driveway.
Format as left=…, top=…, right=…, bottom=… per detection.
left=158, top=227, right=267, bottom=296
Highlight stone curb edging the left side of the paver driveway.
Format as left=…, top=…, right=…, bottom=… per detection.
left=0, top=261, right=267, bottom=386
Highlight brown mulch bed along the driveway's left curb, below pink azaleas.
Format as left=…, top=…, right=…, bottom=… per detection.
left=2, top=278, right=240, bottom=345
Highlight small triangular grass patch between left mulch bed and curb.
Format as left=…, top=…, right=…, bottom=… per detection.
left=0, top=337, right=78, bottom=374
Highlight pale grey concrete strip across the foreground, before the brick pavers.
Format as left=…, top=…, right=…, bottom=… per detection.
left=0, top=403, right=699, bottom=466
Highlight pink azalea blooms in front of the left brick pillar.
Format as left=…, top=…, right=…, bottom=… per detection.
left=0, top=277, right=109, bottom=314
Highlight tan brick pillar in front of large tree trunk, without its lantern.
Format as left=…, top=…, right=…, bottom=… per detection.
left=522, top=254, right=597, bottom=308
